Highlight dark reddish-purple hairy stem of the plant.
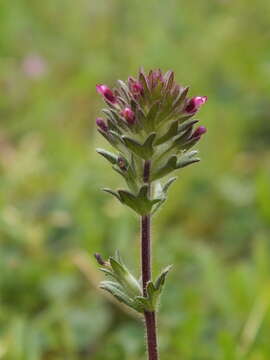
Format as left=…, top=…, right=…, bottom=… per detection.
left=141, top=161, right=158, bottom=360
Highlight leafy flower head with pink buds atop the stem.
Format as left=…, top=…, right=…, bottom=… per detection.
left=97, top=70, right=207, bottom=215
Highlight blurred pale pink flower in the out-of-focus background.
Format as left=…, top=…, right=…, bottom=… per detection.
left=22, top=54, right=47, bottom=79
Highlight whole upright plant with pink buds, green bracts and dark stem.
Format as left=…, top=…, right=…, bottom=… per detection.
left=95, top=70, right=207, bottom=360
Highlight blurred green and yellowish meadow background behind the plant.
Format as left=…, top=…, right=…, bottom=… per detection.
left=0, top=0, right=270, bottom=360
